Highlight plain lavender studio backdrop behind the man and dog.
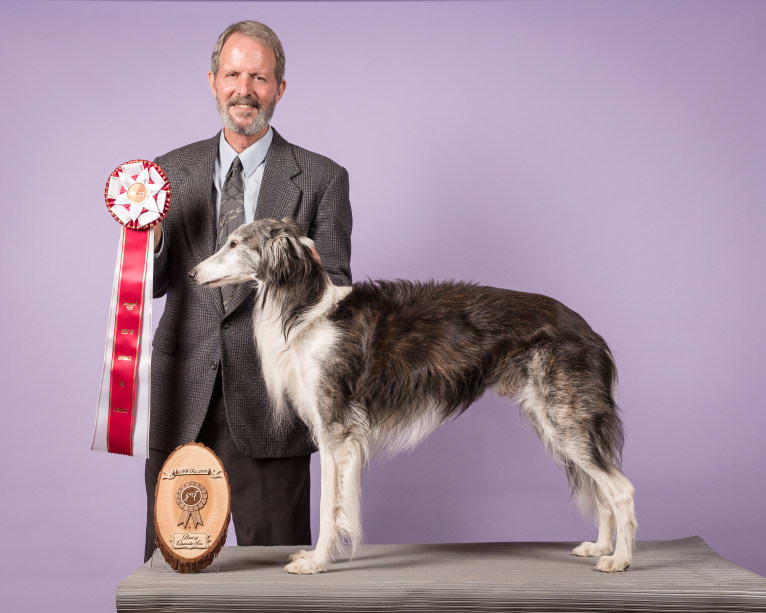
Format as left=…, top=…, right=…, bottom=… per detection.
left=0, top=1, right=766, bottom=611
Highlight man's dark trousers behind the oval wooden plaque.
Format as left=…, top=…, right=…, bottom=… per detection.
left=144, top=372, right=311, bottom=561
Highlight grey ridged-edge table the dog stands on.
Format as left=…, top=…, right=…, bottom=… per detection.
left=117, top=537, right=766, bottom=613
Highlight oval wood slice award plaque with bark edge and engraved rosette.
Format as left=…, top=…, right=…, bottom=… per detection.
left=154, top=443, right=231, bottom=573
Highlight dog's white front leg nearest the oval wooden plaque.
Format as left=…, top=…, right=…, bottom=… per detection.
left=285, top=444, right=338, bottom=575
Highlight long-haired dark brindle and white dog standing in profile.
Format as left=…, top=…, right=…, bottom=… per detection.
left=189, top=218, right=637, bottom=574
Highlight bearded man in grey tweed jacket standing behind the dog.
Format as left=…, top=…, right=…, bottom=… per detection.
left=145, top=21, right=351, bottom=559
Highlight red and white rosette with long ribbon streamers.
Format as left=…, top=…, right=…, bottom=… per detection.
left=91, top=160, right=171, bottom=457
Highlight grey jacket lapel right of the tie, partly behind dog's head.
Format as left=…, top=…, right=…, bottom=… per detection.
left=226, top=130, right=301, bottom=315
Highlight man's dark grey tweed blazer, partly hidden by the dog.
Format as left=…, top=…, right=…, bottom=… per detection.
left=149, top=130, right=352, bottom=458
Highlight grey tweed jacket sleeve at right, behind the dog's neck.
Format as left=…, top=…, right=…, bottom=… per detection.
left=310, top=166, right=353, bottom=285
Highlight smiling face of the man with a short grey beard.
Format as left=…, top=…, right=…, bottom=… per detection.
left=208, top=33, right=285, bottom=135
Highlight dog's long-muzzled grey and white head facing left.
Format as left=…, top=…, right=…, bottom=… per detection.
left=194, top=217, right=321, bottom=287
